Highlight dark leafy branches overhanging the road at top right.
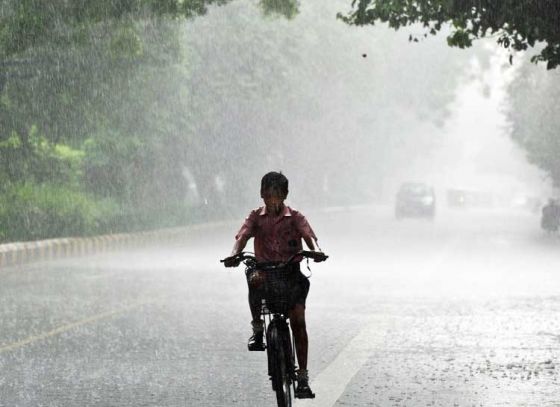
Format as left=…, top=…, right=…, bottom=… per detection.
left=339, top=0, right=560, bottom=69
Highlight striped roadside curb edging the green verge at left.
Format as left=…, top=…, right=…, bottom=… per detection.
left=0, top=221, right=231, bottom=270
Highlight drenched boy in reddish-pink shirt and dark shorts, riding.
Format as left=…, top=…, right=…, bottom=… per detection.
left=224, top=172, right=317, bottom=398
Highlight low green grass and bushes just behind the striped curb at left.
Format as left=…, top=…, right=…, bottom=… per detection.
left=0, top=182, right=199, bottom=243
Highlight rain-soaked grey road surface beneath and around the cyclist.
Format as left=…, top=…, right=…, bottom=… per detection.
left=0, top=207, right=560, bottom=407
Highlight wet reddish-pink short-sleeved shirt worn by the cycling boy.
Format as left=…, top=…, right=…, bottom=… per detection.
left=235, top=206, right=317, bottom=262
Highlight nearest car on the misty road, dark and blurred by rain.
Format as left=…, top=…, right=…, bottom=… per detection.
left=395, top=182, right=436, bottom=219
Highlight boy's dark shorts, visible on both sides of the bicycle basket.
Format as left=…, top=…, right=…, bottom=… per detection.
left=247, top=263, right=310, bottom=308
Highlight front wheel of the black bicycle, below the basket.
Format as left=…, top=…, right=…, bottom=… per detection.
left=268, top=326, right=292, bottom=407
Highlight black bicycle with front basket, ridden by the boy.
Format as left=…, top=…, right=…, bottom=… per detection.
left=221, top=250, right=328, bottom=407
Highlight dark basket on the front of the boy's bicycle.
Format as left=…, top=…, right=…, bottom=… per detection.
left=263, top=269, right=293, bottom=314
